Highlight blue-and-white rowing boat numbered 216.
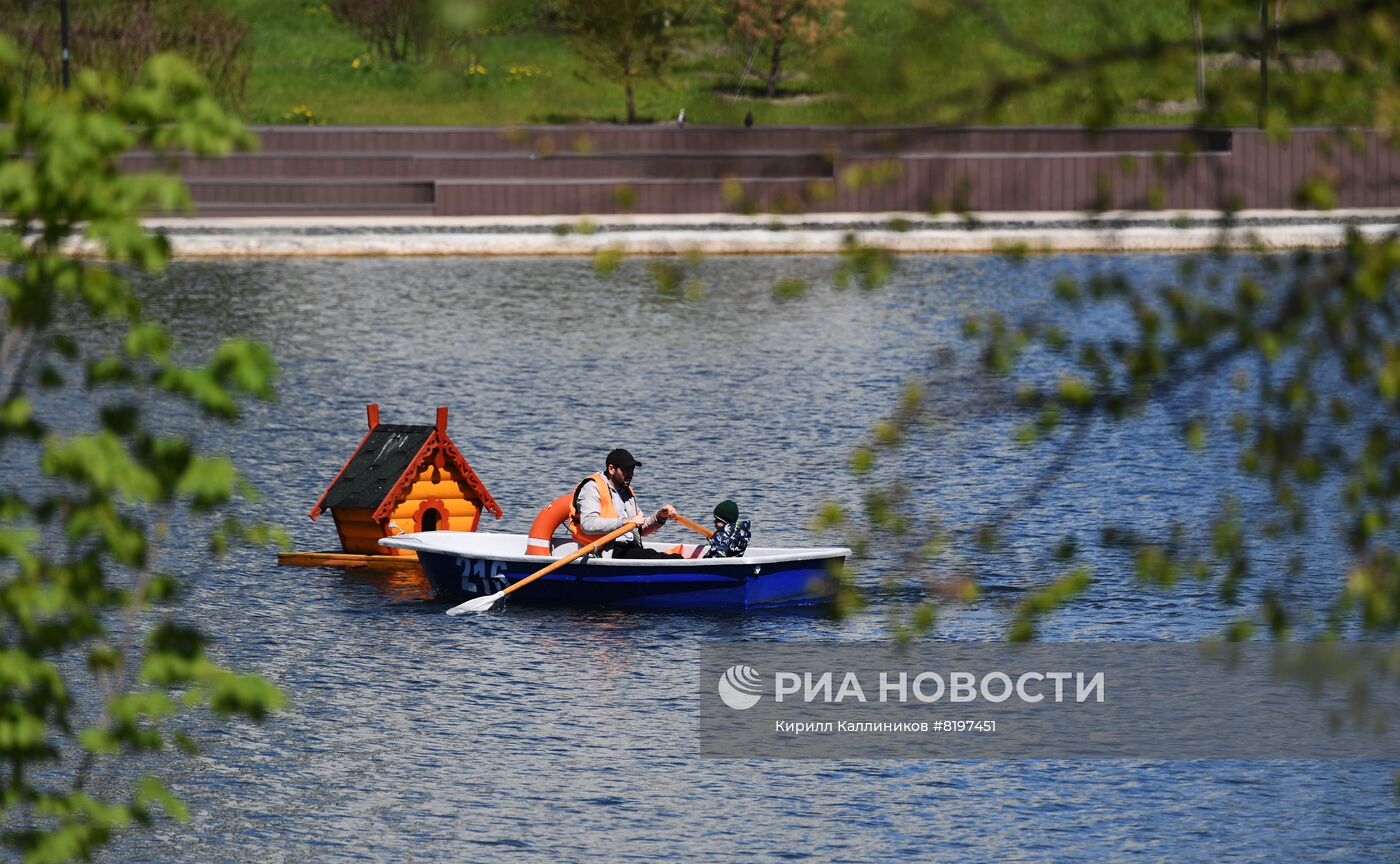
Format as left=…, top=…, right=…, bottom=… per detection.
left=379, top=531, right=851, bottom=612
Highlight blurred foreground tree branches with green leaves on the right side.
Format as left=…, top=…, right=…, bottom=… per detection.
left=817, top=0, right=1400, bottom=640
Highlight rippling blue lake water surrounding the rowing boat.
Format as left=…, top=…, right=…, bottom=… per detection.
left=30, top=256, right=1400, bottom=861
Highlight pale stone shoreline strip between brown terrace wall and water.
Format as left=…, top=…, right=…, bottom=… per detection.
left=143, top=209, right=1400, bottom=259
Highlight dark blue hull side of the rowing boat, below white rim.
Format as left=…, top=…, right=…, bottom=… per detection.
left=419, top=549, right=841, bottom=612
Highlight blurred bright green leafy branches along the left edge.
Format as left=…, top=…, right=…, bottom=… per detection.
left=0, top=38, right=284, bottom=861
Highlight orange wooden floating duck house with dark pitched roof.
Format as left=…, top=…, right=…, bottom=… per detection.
left=311, top=405, right=501, bottom=556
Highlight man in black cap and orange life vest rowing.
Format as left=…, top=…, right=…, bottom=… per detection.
left=566, top=447, right=680, bottom=559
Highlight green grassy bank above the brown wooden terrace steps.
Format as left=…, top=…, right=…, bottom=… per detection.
left=228, top=0, right=1369, bottom=125
